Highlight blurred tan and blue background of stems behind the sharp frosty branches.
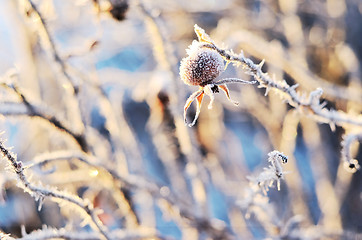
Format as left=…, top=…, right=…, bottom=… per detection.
left=0, top=0, right=362, bottom=239
